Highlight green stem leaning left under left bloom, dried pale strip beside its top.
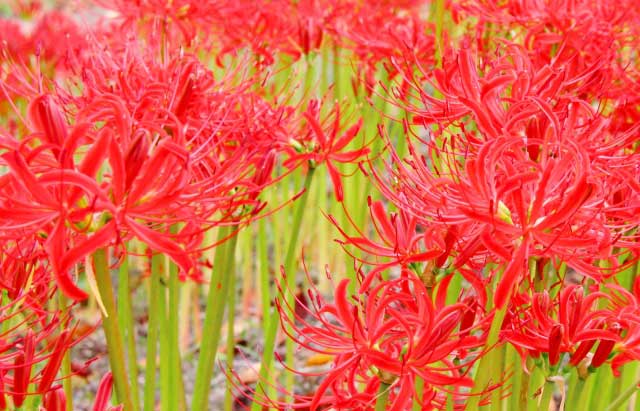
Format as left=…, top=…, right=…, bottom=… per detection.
left=93, top=248, right=135, bottom=411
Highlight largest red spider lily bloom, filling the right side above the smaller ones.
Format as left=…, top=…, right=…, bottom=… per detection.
left=375, top=43, right=637, bottom=305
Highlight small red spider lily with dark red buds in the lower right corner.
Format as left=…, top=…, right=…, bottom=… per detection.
left=500, top=285, right=620, bottom=367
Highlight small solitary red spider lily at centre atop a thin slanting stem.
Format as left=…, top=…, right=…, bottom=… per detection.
left=284, top=100, right=369, bottom=202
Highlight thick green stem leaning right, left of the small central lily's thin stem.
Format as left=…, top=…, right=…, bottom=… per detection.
left=191, top=226, right=238, bottom=411
